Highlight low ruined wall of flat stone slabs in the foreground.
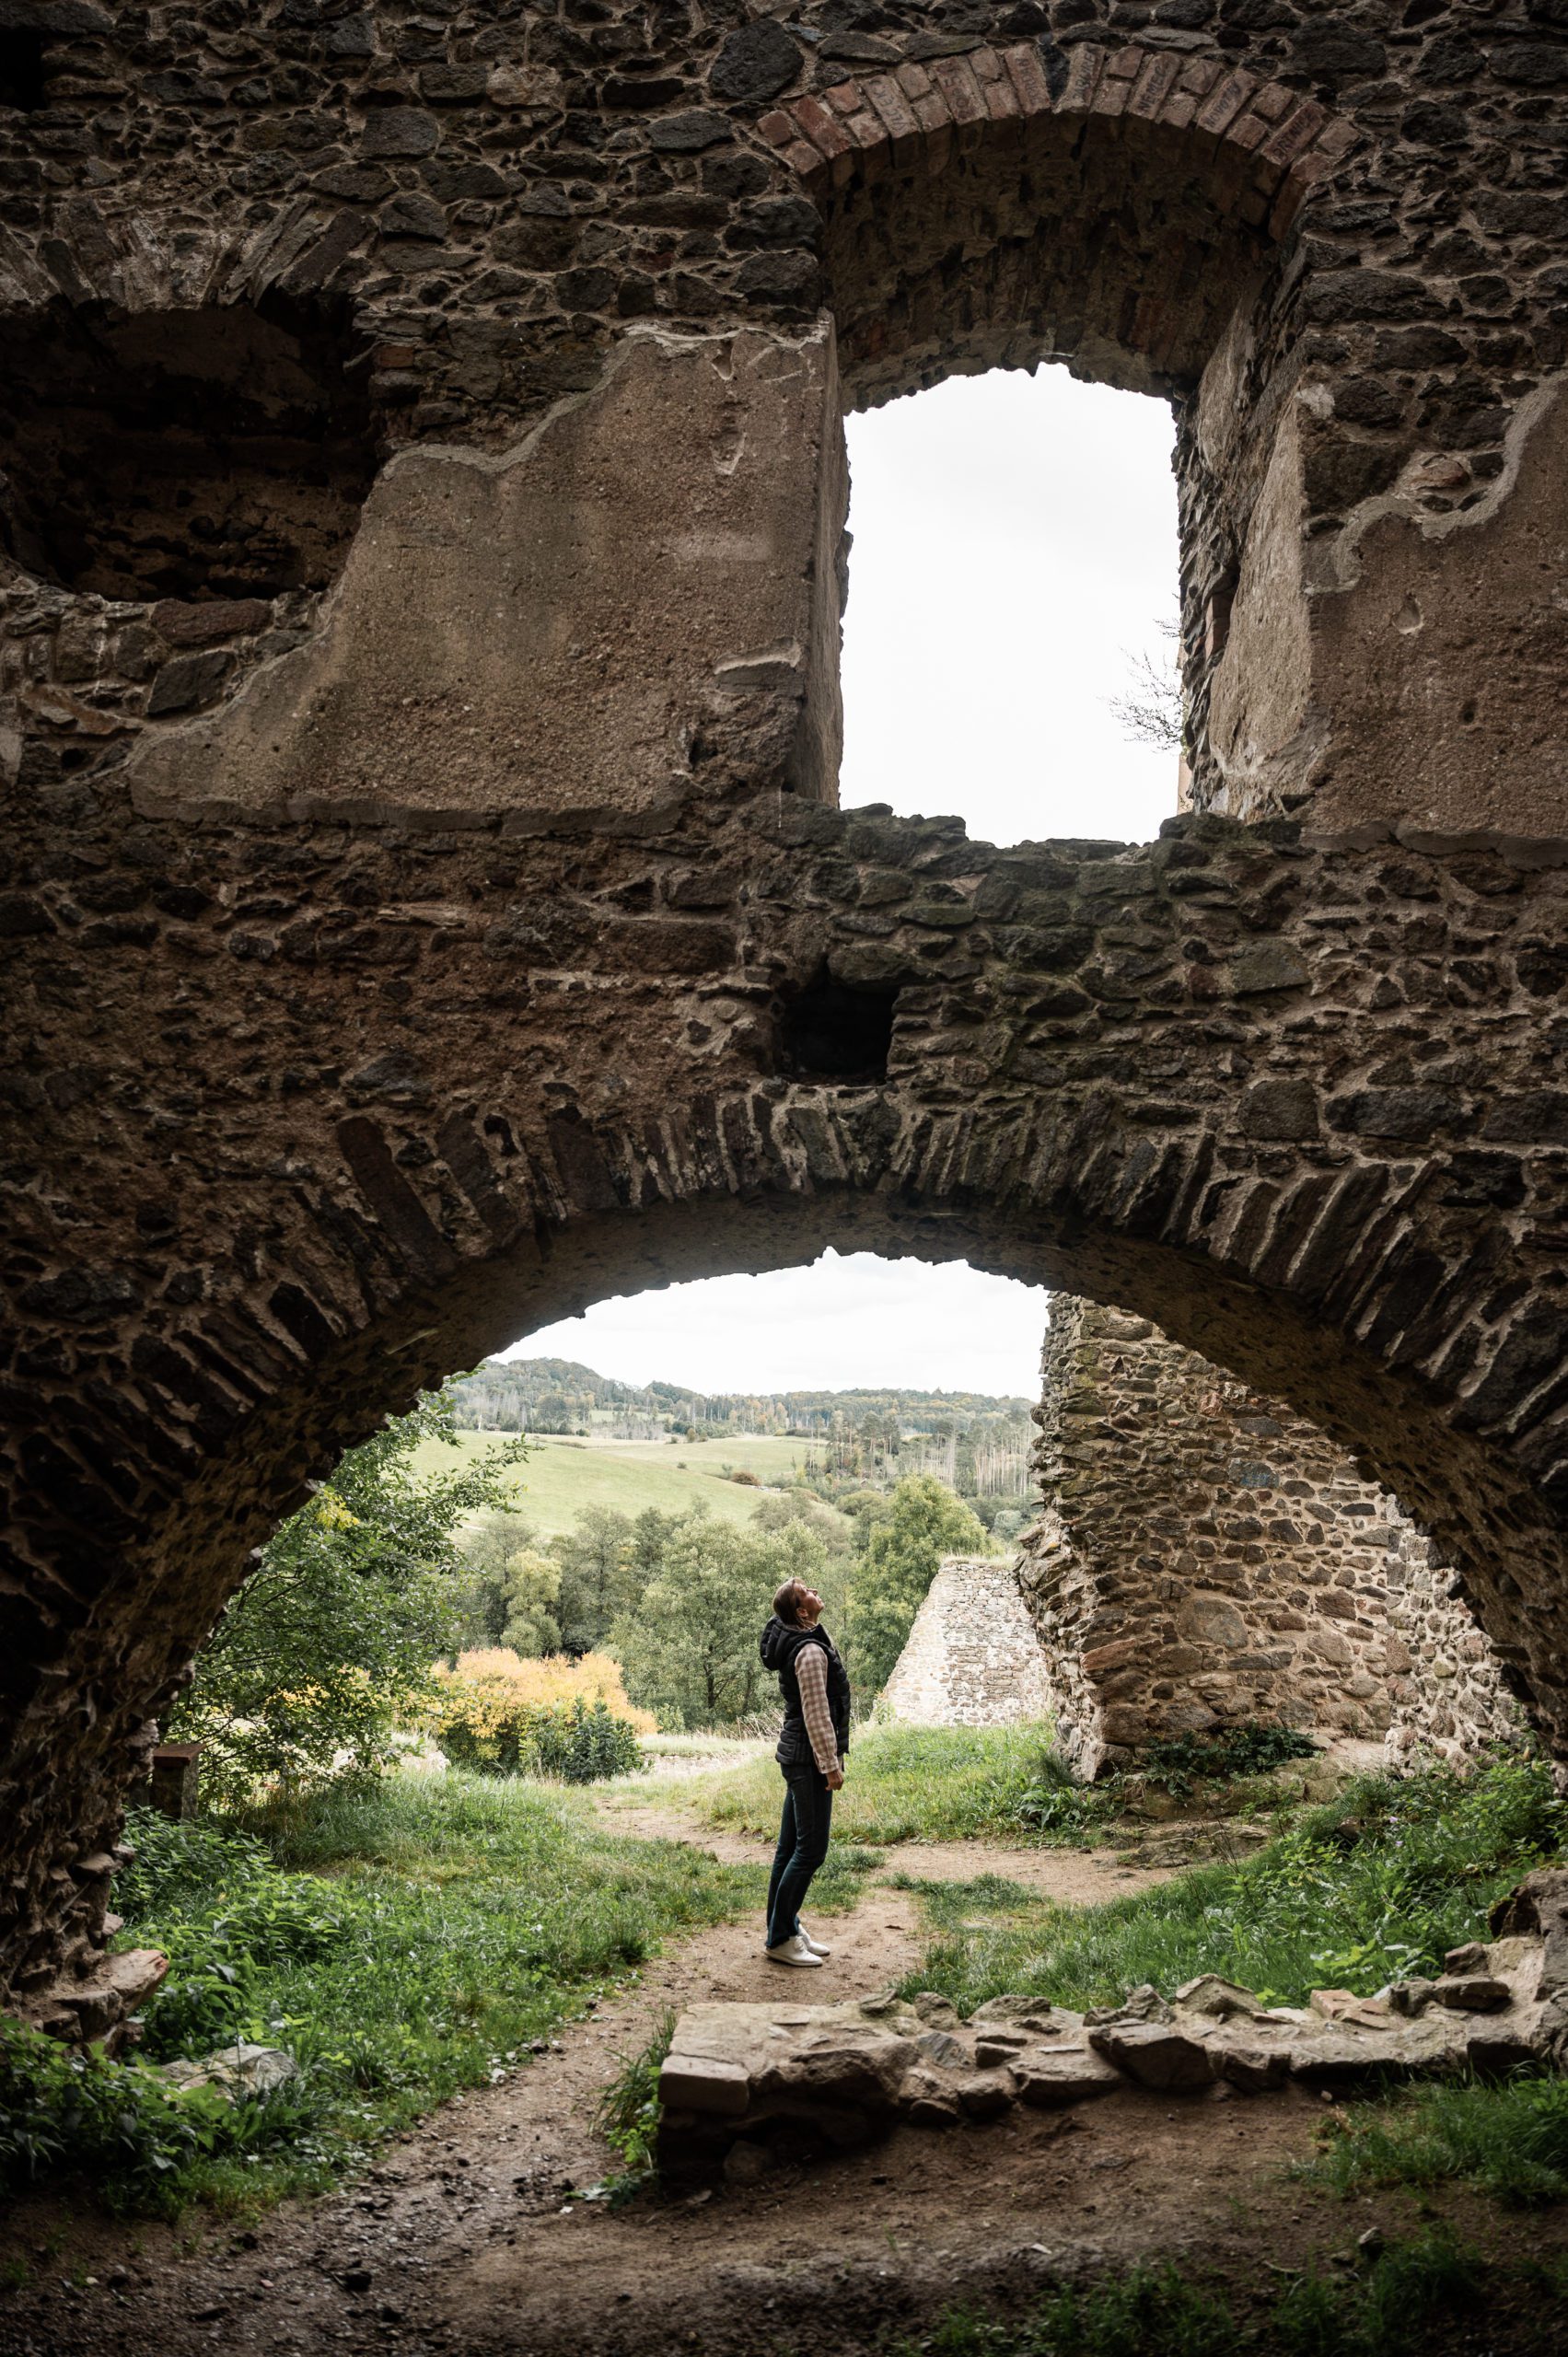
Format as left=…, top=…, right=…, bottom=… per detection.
left=657, top=1867, right=1568, bottom=2180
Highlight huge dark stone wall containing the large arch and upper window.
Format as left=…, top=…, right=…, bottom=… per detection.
left=0, top=0, right=1568, bottom=2003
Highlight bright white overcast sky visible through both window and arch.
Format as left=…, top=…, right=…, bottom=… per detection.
left=509, top=367, right=1177, bottom=1398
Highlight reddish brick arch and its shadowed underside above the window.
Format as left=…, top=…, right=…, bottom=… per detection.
left=757, top=42, right=1361, bottom=401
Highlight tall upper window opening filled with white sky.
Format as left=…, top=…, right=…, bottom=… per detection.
left=840, top=367, right=1181, bottom=843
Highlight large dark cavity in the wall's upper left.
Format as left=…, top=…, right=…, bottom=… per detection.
left=0, top=304, right=375, bottom=598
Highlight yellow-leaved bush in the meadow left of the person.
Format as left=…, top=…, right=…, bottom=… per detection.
left=434, top=1645, right=653, bottom=1784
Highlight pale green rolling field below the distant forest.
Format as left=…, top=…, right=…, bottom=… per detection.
left=415, top=1433, right=849, bottom=1539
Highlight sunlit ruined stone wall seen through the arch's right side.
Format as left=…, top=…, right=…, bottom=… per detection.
left=1021, top=1296, right=1518, bottom=1772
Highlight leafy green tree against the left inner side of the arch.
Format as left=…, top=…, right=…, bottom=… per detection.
left=168, top=1390, right=526, bottom=1801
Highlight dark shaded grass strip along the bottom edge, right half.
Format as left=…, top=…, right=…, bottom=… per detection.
left=887, top=2227, right=1527, bottom=2357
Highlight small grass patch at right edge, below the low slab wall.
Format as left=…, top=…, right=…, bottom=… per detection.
left=1304, top=2074, right=1568, bottom=2209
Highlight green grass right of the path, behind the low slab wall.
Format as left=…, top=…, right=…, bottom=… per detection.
left=905, top=1756, right=1568, bottom=2013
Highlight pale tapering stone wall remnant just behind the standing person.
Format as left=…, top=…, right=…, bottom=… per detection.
left=882, top=1556, right=1051, bottom=1727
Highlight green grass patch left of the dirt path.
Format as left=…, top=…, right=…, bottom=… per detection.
left=0, top=1775, right=764, bottom=2213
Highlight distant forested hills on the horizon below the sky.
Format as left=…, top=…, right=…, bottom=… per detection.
left=453, top=1358, right=1033, bottom=1497
